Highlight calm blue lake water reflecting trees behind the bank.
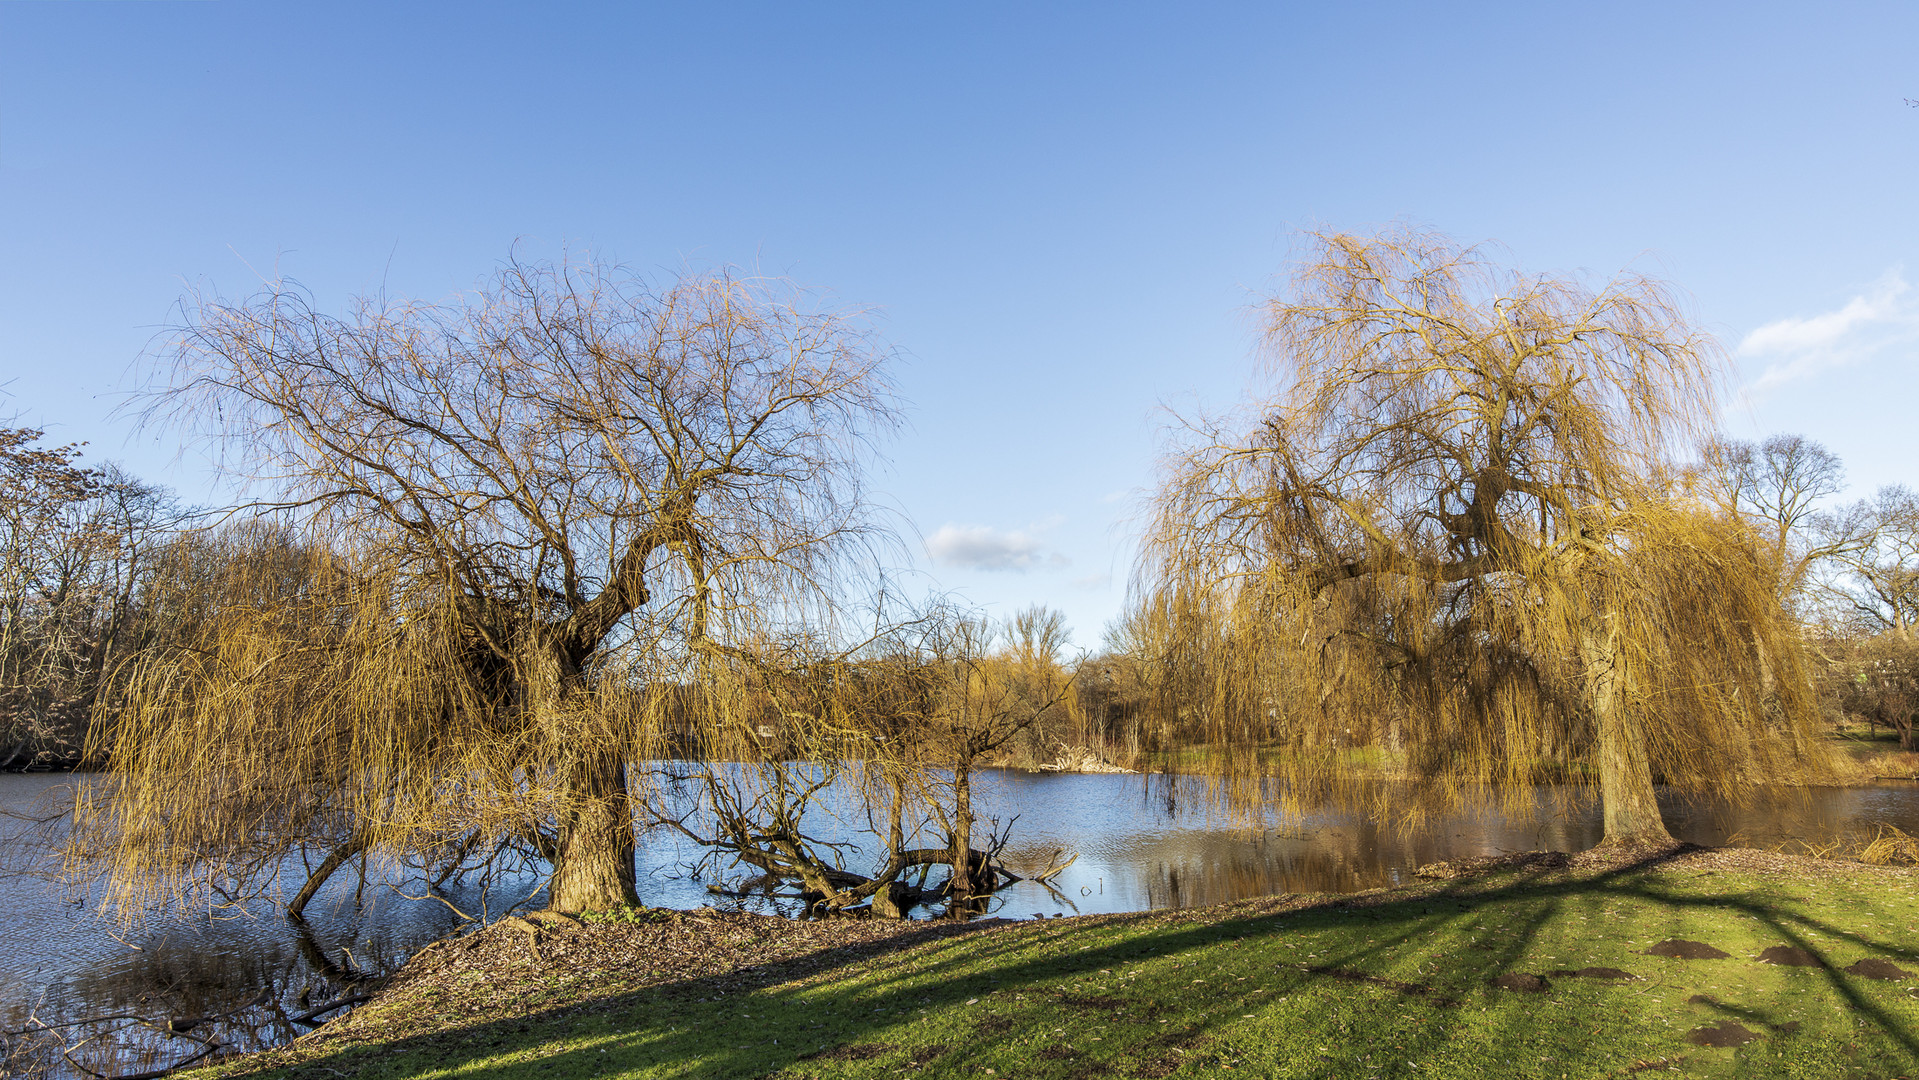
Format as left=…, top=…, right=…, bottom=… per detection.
left=0, top=771, right=1919, bottom=1074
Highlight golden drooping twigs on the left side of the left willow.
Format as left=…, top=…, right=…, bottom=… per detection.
left=73, top=524, right=548, bottom=909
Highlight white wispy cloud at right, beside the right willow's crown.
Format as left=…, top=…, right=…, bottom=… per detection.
left=1737, top=267, right=1919, bottom=393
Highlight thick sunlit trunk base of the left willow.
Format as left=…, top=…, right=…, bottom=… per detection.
left=547, top=744, right=639, bottom=911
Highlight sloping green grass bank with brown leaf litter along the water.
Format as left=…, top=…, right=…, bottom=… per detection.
left=190, top=848, right=1919, bottom=1080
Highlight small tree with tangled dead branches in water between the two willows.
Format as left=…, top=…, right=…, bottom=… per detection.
left=660, top=606, right=1071, bottom=915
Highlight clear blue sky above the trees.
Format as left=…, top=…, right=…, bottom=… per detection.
left=0, top=4, right=1919, bottom=646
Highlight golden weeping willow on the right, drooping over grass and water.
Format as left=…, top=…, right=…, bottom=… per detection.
left=1134, top=228, right=1827, bottom=844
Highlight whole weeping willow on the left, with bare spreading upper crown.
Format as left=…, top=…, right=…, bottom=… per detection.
left=77, top=261, right=892, bottom=911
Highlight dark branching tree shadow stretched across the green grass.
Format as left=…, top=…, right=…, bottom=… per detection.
left=217, top=856, right=1919, bottom=1080
